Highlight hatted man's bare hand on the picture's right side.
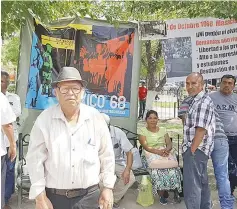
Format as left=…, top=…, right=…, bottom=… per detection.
left=99, top=188, right=114, bottom=209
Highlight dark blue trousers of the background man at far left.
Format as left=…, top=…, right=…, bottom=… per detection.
left=5, top=149, right=16, bottom=204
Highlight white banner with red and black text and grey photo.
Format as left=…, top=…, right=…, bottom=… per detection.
left=162, top=18, right=237, bottom=81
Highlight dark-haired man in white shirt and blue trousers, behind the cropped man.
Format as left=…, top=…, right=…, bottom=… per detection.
left=1, top=71, right=21, bottom=208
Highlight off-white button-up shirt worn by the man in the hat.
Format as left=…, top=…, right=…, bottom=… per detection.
left=26, top=104, right=116, bottom=199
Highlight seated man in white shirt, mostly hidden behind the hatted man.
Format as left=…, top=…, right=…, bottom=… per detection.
left=101, top=113, right=135, bottom=208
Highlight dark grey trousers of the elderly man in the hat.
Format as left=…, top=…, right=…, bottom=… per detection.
left=46, top=189, right=100, bottom=209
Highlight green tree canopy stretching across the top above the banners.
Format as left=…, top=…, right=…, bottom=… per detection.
left=1, top=0, right=237, bottom=36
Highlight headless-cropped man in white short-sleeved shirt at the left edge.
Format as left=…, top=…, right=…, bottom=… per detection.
left=0, top=92, right=16, bottom=208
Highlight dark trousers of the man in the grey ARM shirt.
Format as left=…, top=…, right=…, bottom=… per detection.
left=227, top=136, right=237, bottom=194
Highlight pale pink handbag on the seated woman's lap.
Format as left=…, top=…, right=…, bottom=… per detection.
left=144, top=147, right=178, bottom=169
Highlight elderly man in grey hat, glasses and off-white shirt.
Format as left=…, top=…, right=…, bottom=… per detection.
left=27, top=67, right=116, bottom=209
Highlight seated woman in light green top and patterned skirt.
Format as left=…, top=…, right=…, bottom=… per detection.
left=138, top=110, right=182, bottom=205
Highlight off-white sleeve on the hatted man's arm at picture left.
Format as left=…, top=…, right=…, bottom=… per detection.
left=26, top=121, right=47, bottom=199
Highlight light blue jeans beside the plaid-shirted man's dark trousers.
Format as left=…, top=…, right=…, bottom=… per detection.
left=211, top=139, right=234, bottom=209
